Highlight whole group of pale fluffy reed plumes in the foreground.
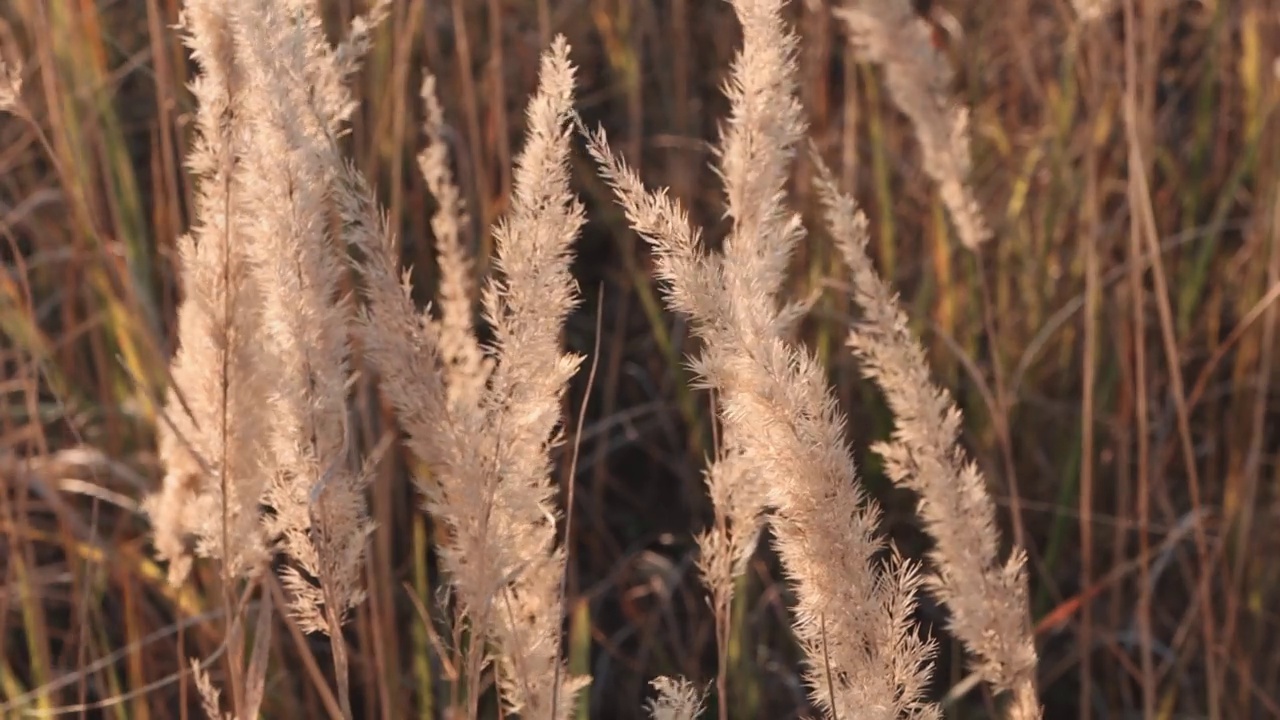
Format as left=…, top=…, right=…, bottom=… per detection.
left=120, top=0, right=1041, bottom=720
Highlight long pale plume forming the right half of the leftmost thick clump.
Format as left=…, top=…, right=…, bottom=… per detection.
left=236, top=0, right=371, bottom=644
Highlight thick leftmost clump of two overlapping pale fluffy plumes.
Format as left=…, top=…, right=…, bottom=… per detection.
left=147, top=0, right=387, bottom=717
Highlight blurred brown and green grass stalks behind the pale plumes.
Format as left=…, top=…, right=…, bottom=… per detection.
left=0, top=0, right=1280, bottom=719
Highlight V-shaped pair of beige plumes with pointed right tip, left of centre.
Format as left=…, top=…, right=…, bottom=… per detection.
left=357, top=38, right=585, bottom=720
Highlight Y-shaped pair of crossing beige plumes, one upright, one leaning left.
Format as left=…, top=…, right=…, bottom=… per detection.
left=589, top=0, right=938, bottom=719
